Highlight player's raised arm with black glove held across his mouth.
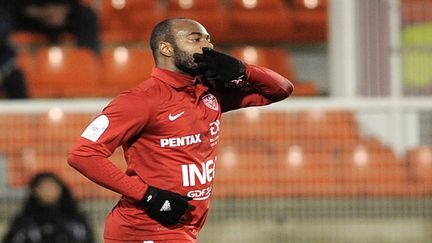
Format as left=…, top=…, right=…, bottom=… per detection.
left=194, top=48, right=294, bottom=112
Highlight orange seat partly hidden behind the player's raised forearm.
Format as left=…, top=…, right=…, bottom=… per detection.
left=230, top=46, right=318, bottom=96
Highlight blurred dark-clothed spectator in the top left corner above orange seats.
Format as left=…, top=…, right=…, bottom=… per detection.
left=0, top=0, right=100, bottom=52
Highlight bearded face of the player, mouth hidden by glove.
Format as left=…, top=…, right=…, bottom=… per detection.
left=172, top=20, right=213, bottom=76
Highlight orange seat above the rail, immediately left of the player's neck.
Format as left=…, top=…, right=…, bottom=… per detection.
left=102, top=47, right=154, bottom=95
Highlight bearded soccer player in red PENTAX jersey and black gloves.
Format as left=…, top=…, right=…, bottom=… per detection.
left=68, top=18, right=293, bottom=243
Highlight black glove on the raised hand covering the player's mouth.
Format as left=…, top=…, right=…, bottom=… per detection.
left=193, top=47, right=246, bottom=82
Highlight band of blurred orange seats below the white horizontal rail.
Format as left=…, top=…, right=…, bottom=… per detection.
left=0, top=111, right=432, bottom=199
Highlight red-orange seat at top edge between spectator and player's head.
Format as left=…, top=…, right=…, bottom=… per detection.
left=100, top=0, right=165, bottom=43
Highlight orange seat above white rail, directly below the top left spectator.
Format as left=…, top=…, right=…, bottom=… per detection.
left=28, top=47, right=105, bottom=98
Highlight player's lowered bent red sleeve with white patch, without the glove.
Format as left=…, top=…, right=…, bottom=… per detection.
left=68, top=95, right=149, bottom=200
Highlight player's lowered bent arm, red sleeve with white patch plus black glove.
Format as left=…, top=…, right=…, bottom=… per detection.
left=68, top=92, right=191, bottom=226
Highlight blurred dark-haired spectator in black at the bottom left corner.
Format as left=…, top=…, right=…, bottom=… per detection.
left=3, top=173, right=94, bottom=243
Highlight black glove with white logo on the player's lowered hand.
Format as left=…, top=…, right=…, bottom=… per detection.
left=143, top=186, right=192, bottom=226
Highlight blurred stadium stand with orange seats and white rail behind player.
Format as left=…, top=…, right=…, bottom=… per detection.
left=0, top=0, right=432, bottom=243
